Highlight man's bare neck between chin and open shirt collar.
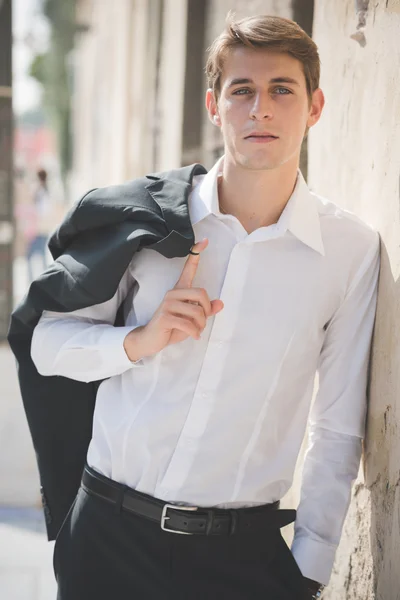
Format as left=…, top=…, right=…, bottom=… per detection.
left=218, top=158, right=298, bottom=233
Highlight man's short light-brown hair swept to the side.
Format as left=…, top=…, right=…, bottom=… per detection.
left=206, top=12, right=320, bottom=101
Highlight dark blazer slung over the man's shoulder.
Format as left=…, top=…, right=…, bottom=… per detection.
left=8, top=164, right=207, bottom=539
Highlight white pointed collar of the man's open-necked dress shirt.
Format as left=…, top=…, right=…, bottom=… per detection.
left=189, top=157, right=325, bottom=256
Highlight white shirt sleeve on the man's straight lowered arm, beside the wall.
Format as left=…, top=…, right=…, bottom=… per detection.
left=292, top=235, right=380, bottom=584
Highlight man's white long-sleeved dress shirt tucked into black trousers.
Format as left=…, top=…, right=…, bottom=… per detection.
left=32, top=159, right=379, bottom=583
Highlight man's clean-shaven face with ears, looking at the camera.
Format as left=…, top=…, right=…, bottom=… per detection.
left=206, top=48, right=324, bottom=170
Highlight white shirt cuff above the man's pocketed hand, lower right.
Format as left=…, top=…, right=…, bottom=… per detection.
left=292, top=536, right=337, bottom=585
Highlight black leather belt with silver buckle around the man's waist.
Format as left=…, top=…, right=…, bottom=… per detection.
left=81, top=466, right=296, bottom=535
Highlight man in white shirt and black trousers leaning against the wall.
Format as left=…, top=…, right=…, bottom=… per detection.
left=28, top=16, right=379, bottom=600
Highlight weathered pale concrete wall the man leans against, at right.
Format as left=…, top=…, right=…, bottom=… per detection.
left=309, top=0, right=400, bottom=600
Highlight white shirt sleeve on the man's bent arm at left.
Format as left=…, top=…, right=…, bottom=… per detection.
left=31, top=269, right=142, bottom=382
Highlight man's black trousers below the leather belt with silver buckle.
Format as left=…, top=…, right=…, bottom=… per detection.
left=54, top=480, right=307, bottom=600
